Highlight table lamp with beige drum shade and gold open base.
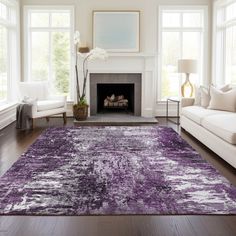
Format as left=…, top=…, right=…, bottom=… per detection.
left=178, top=59, right=197, bottom=97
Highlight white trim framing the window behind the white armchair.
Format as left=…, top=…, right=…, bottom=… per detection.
left=23, top=5, right=75, bottom=101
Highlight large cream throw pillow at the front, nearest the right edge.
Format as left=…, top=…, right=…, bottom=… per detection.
left=208, top=86, right=236, bottom=112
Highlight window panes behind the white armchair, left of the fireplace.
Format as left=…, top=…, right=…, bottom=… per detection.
left=25, top=7, right=74, bottom=99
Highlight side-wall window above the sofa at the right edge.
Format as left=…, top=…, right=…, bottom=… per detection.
left=213, top=0, right=236, bottom=85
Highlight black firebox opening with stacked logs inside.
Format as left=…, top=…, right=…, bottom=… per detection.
left=97, top=83, right=134, bottom=113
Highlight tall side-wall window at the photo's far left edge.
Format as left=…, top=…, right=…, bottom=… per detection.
left=0, top=0, right=19, bottom=105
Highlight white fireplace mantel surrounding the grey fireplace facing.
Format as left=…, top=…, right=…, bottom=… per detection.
left=80, top=52, right=158, bottom=117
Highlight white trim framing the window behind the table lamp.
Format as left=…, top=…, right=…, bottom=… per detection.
left=156, top=5, right=209, bottom=104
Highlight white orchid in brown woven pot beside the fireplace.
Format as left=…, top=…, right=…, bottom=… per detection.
left=73, top=31, right=108, bottom=120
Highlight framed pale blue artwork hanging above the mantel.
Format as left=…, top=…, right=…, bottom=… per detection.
left=93, top=10, right=140, bottom=52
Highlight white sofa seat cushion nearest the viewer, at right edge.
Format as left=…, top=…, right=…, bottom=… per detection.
left=202, top=112, right=236, bottom=144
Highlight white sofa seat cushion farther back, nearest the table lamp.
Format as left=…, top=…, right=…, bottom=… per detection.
left=182, top=106, right=229, bottom=125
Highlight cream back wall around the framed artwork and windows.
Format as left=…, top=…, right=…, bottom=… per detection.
left=21, top=0, right=212, bottom=116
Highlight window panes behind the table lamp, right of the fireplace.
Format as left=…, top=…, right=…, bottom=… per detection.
left=158, top=7, right=207, bottom=101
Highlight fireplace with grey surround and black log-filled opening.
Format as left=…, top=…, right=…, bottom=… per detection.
left=90, top=73, right=142, bottom=116
